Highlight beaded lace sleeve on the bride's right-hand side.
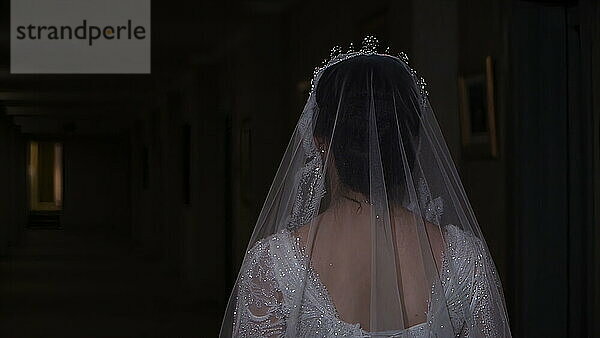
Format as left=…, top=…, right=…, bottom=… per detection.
left=445, top=226, right=510, bottom=337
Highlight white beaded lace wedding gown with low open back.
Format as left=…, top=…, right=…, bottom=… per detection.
left=233, top=225, right=501, bottom=337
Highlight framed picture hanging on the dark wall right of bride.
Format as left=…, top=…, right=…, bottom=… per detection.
left=458, top=56, right=499, bottom=160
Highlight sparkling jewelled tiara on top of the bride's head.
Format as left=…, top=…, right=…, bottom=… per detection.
left=310, top=35, right=429, bottom=105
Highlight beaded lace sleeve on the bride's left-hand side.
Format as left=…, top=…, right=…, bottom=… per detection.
left=233, top=240, right=285, bottom=337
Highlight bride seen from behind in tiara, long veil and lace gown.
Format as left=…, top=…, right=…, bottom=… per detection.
left=221, top=37, right=510, bottom=337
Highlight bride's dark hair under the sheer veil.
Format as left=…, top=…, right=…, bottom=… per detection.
left=314, top=55, right=420, bottom=202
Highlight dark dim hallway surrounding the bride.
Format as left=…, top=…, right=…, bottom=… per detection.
left=0, top=0, right=600, bottom=338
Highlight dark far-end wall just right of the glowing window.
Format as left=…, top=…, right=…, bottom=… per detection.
left=61, top=136, right=130, bottom=237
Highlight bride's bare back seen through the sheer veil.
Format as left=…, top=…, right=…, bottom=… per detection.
left=296, top=201, right=443, bottom=330
